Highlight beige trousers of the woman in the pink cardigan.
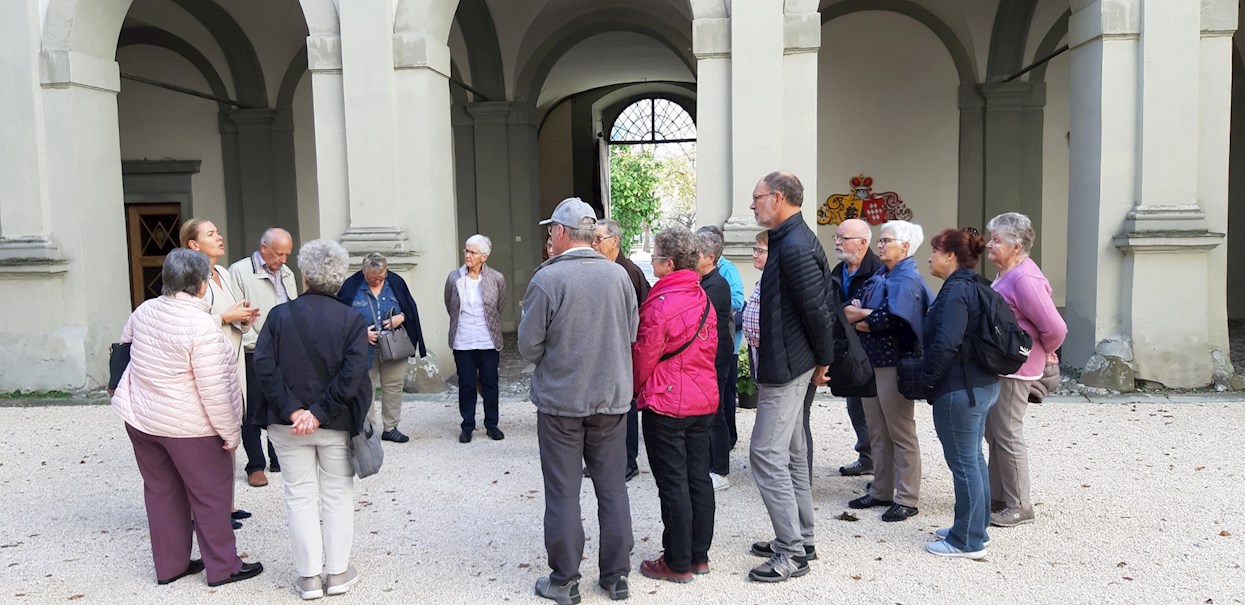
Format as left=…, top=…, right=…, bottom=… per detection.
left=986, top=378, right=1033, bottom=508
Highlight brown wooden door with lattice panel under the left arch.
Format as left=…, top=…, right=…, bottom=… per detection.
left=126, top=203, right=182, bottom=309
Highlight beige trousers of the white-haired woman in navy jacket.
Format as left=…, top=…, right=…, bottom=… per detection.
left=860, top=367, right=921, bottom=508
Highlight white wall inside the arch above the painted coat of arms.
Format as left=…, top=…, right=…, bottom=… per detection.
left=804, top=11, right=960, bottom=283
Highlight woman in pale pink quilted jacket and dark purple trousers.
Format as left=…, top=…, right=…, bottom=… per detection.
left=112, top=249, right=264, bottom=586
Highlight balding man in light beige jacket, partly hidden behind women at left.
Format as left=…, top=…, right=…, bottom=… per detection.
left=229, top=227, right=299, bottom=487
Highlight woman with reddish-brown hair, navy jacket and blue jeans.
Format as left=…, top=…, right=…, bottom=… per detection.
left=920, top=229, right=998, bottom=559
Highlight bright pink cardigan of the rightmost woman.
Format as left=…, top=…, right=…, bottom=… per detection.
left=992, top=258, right=1068, bottom=380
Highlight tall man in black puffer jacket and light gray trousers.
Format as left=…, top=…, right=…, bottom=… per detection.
left=748, top=172, right=834, bottom=581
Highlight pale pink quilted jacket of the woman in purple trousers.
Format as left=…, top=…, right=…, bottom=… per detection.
left=112, top=294, right=242, bottom=447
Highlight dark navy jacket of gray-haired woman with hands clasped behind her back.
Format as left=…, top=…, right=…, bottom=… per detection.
left=250, top=291, right=372, bottom=434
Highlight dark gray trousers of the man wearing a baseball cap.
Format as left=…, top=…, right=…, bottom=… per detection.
left=537, top=413, right=635, bottom=585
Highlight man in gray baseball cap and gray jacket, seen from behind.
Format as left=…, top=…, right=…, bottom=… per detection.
left=519, top=198, right=640, bottom=605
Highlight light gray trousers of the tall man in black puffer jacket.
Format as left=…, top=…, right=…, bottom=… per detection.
left=748, top=370, right=813, bottom=556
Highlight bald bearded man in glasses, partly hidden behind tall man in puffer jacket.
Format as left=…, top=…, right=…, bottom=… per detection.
left=826, top=219, right=885, bottom=477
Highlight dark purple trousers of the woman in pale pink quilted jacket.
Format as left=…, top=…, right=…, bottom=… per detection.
left=126, top=423, right=242, bottom=581
